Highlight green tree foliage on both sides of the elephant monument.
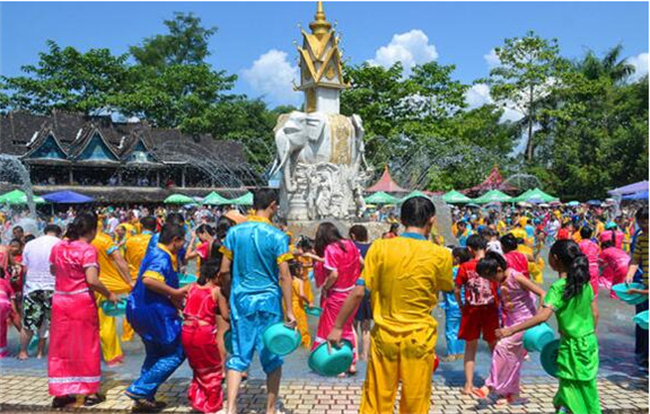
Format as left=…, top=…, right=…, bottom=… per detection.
left=0, top=14, right=649, bottom=199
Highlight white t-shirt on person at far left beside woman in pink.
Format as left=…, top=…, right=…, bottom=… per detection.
left=23, top=235, right=60, bottom=295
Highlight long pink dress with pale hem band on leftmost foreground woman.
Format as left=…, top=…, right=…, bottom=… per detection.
left=48, top=240, right=101, bottom=397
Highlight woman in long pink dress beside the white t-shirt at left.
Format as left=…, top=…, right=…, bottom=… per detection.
left=48, top=213, right=117, bottom=408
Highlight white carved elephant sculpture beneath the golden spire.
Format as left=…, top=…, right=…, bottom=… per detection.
left=270, top=111, right=368, bottom=220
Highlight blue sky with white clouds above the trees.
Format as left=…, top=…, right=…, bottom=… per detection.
left=0, top=2, right=648, bottom=105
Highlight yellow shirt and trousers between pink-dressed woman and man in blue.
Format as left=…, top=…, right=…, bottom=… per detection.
left=92, top=223, right=133, bottom=366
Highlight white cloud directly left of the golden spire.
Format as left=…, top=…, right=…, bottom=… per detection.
left=242, top=49, right=302, bottom=105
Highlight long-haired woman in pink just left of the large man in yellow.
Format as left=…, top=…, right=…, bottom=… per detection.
left=312, top=222, right=361, bottom=374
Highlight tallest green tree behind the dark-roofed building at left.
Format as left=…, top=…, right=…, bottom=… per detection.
left=111, top=13, right=237, bottom=133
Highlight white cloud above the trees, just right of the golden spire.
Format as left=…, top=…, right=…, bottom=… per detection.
left=369, top=29, right=438, bottom=75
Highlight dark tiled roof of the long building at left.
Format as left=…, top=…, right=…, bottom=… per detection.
left=0, top=111, right=247, bottom=167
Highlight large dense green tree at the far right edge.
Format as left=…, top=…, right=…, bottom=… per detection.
left=532, top=48, right=649, bottom=199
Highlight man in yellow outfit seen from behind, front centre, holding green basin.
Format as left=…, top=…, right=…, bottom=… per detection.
left=327, top=197, right=453, bottom=414
